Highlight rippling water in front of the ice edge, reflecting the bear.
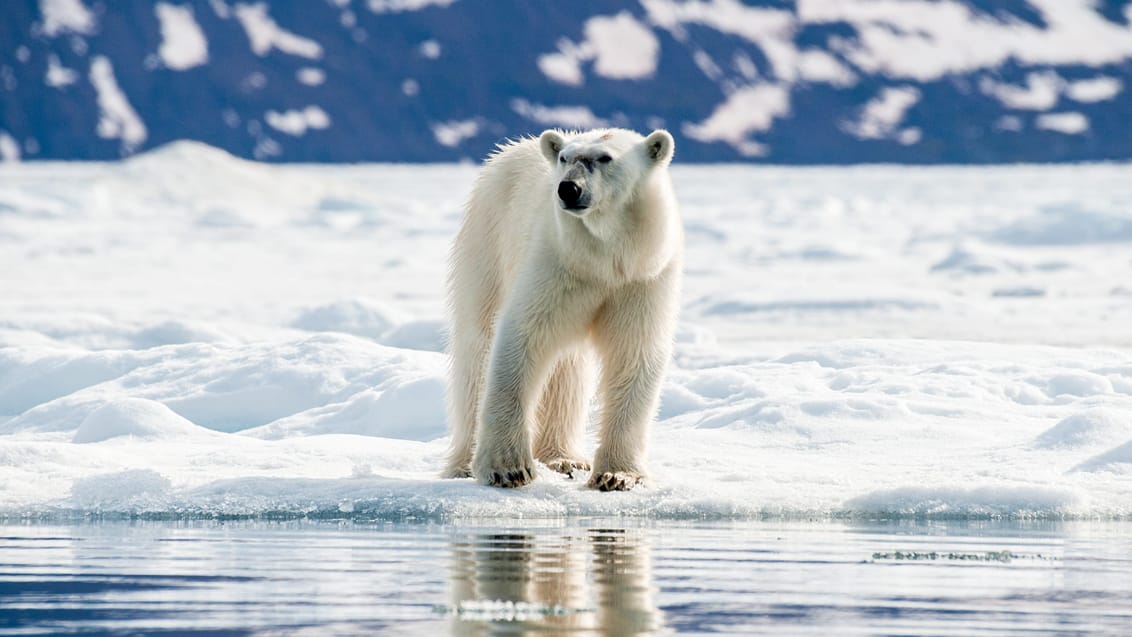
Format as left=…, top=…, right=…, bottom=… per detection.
left=0, top=519, right=1132, bottom=636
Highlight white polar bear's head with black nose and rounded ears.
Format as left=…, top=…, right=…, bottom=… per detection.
left=539, top=128, right=676, bottom=217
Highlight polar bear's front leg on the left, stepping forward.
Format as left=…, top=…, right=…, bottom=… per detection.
left=472, top=273, right=595, bottom=487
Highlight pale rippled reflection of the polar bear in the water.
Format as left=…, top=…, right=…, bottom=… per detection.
left=449, top=530, right=661, bottom=636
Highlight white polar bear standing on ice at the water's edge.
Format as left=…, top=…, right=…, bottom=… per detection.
left=444, top=129, right=684, bottom=491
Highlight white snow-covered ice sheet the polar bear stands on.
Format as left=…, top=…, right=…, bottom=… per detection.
left=0, top=144, right=1132, bottom=519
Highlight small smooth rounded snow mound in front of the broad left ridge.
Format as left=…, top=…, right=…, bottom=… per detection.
left=71, top=398, right=207, bottom=444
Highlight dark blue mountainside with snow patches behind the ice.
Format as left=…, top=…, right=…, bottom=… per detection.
left=0, top=0, right=1132, bottom=164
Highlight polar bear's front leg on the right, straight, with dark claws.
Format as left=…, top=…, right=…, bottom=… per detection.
left=589, top=267, right=678, bottom=491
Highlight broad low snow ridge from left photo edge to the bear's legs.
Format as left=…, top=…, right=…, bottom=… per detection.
left=0, top=334, right=443, bottom=432
